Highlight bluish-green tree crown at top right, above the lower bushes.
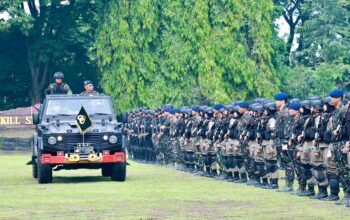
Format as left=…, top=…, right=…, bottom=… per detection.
left=294, top=0, right=350, bottom=68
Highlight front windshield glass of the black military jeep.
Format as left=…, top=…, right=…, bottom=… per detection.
left=45, top=99, right=113, bottom=116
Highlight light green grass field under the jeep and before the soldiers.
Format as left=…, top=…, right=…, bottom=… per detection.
left=0, top=154, right=350, bottom=219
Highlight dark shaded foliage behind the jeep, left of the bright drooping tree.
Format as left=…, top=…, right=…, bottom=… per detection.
left=0, top=0, right=101, bottom=109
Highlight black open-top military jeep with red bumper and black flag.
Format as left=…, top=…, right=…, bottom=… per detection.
left=31, top=95, right=126, bottom=183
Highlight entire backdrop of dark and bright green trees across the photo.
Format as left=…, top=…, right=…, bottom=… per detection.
left=0, top=0, right=350, bottom=110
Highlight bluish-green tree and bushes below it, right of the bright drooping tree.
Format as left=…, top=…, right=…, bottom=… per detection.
left=282, top=0, right=350, bottom=97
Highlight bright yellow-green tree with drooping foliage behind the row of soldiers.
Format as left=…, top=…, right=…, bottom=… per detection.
left=96, top=0, right=279, bottom=110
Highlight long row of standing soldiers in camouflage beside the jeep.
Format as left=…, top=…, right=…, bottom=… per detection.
left=125, top=89, right=350, bottom=207
